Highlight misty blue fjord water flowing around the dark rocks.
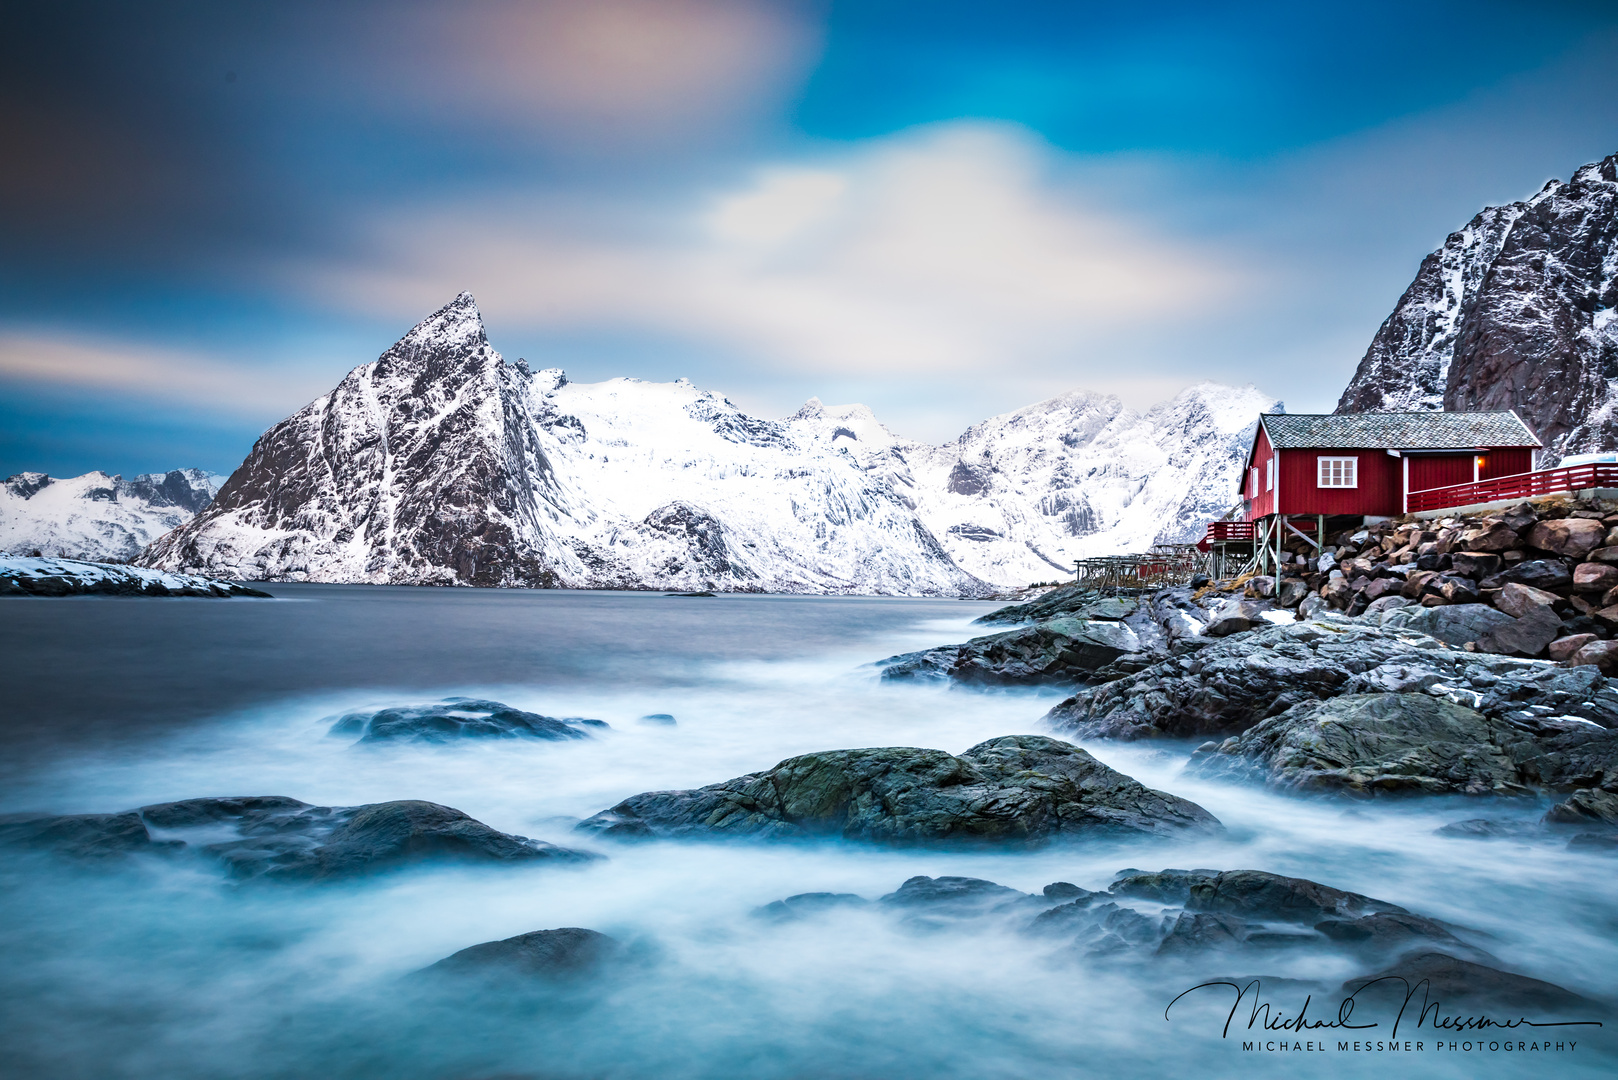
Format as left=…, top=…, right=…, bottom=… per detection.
left=0, top=586, right=1618, bottom=1078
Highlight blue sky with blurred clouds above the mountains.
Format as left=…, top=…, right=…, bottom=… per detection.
left=0, top=0, right=1618, bottom=476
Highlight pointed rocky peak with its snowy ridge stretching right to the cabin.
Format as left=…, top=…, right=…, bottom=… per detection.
left=141, top=293, right=1272, bottom=596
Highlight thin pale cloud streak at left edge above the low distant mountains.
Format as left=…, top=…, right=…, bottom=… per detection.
left=0, top=330, right=333, bottom=418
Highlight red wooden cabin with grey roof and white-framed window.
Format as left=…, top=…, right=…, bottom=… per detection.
left=1239, top=411, right=1540, bottom=521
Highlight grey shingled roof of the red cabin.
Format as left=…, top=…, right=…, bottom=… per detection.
left=1259, top=411, right=1540, bottom=450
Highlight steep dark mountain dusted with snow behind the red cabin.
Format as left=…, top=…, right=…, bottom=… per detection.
left=1336, top=154, right=1618, bottom=463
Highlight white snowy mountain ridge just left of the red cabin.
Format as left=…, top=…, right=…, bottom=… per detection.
left=788, top=382, right=1277, bottom=585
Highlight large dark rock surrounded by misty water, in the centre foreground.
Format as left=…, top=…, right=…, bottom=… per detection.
left=579, top=735, right=1222, bottom=844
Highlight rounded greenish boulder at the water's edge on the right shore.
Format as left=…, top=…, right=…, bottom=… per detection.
left=1189, top=693, right=1532, bottom=797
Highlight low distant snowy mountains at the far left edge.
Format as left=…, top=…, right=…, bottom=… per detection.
left=0, top=470, right=220, bottom=562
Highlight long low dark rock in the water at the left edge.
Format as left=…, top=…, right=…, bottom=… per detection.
left=0, top=795, right=597, bottom=881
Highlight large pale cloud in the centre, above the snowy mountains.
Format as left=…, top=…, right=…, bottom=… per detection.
left=294, top=123, right=1251, bottom=384
